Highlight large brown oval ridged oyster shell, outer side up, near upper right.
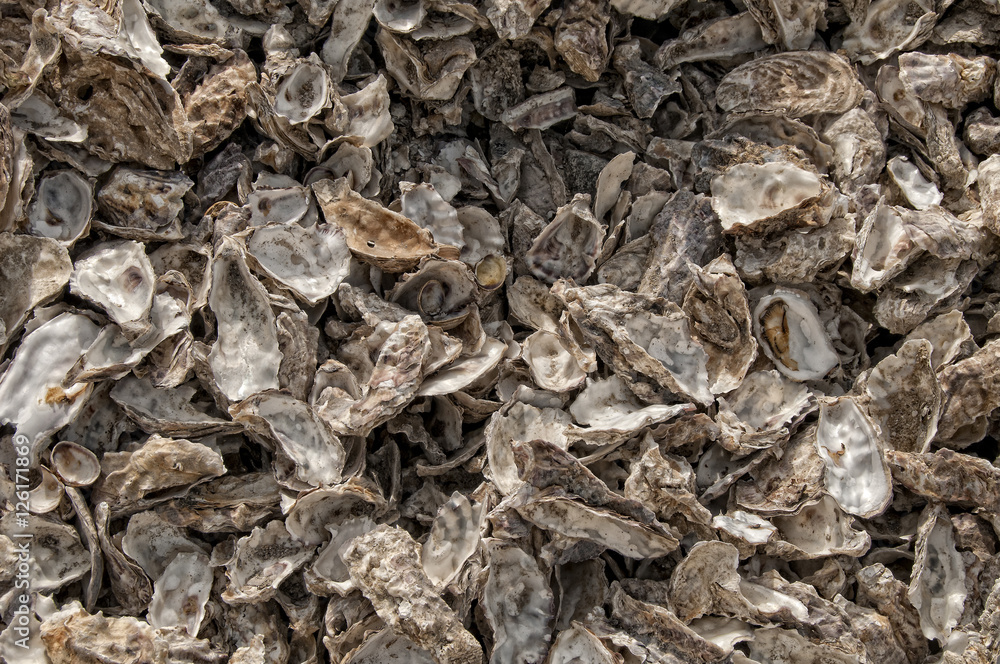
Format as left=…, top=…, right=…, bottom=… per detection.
left=715, top=51, right=864, bottom=118
